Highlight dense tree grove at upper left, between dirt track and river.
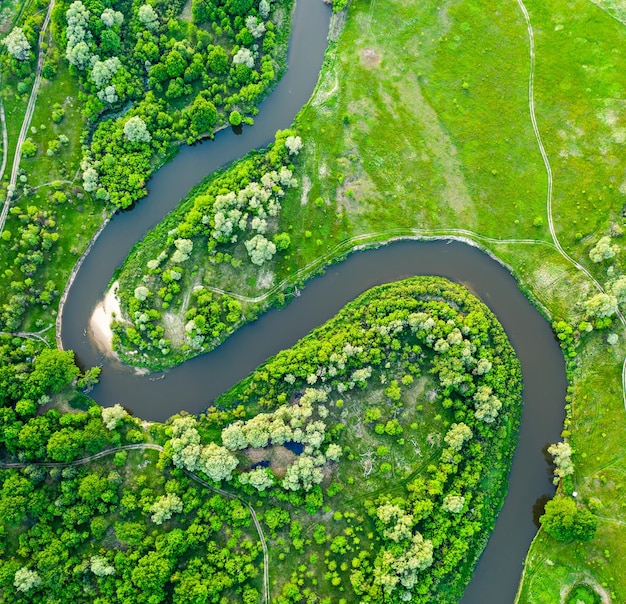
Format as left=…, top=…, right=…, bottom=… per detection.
left=54, top=0, right=290, bottom=208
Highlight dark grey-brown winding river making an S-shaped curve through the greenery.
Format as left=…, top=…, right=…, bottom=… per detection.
left=61, top=0, right=566, bottom=604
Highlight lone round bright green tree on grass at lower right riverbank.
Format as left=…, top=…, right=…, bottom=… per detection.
left=539, top=495, right=598, bottom=541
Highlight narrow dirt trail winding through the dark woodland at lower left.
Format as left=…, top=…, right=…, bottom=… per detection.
left=0, top=443, right=270, bottom=604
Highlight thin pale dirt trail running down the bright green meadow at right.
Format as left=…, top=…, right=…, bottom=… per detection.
left=517, top=0, right=626, bottom=410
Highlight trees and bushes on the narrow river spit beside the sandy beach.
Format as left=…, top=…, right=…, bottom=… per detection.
left=115, top=130, right=297, bottom=366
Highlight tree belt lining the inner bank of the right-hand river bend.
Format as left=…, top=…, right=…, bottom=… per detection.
left=217, top=277, right=521, bottom=603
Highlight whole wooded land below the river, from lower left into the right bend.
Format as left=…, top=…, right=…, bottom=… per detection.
left=0, top=278, right=521, bottom=603
